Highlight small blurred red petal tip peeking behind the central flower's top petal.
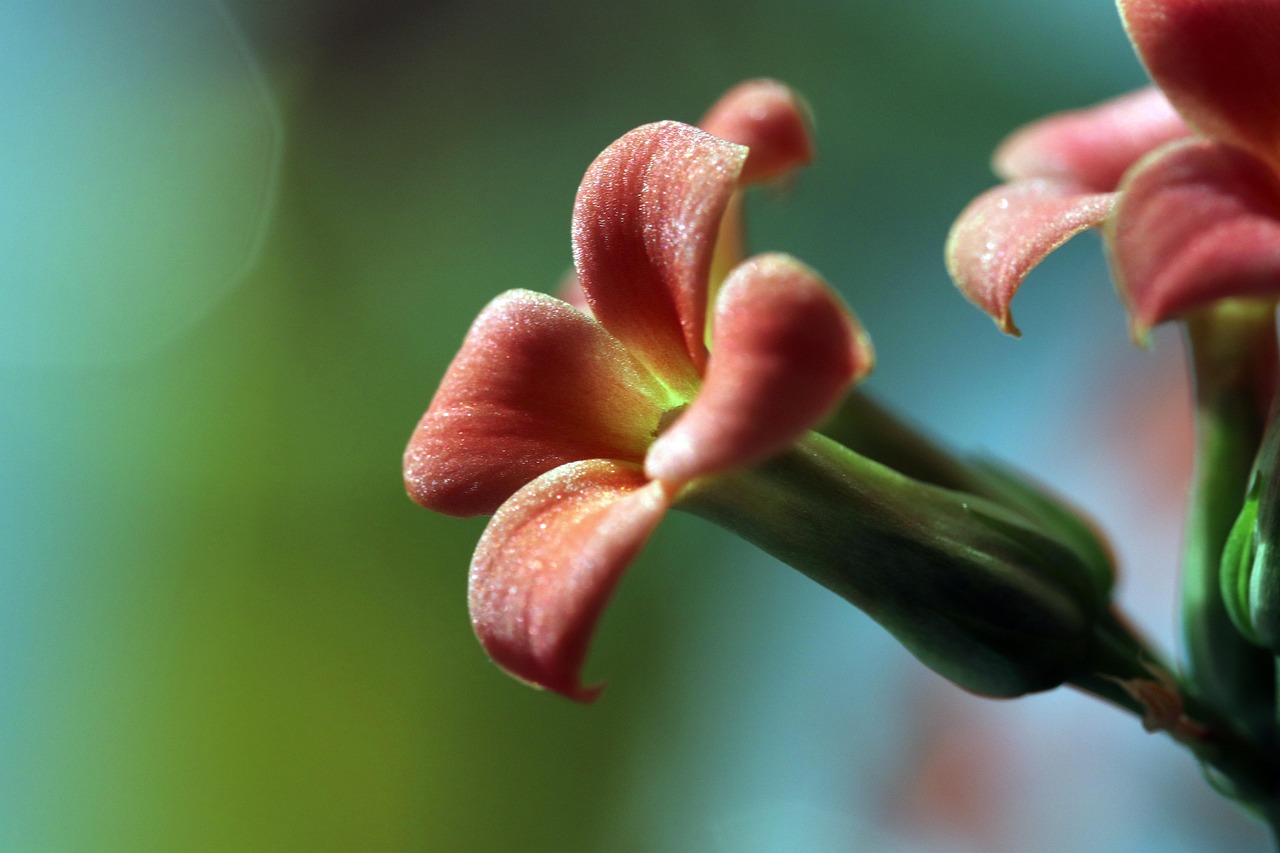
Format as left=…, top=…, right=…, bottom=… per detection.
left=699, top=79, right=813, bottom=183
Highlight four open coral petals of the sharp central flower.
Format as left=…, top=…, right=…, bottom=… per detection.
left=404, top=106, right=872, bottom=701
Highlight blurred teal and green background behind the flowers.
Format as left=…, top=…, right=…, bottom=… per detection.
left=0, top=0, right=1265, bottom=853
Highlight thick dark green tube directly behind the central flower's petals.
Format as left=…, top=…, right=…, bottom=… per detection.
left=677, top=434, right=1110, bottom=697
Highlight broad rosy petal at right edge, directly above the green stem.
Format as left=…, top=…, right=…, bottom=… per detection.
left=1107, top=141, right=1280, bottom=338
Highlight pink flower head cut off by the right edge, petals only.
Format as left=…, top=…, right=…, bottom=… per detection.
left=947, top=0, right=1280, bottom=338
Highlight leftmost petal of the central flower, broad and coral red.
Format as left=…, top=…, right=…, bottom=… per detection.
left=404, top=291, right=671, bottom=516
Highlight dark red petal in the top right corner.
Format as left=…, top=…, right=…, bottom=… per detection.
left=1120, top=0, right=1280, bottom=169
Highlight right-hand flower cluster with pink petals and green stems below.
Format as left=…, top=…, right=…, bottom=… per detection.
left=946, top=0, right=1280, bottom=826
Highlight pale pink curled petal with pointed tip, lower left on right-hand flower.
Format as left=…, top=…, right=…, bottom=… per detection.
left=946, top=178, right=1115, bottom=334
